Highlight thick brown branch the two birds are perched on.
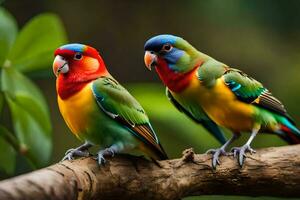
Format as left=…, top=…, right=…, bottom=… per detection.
left=0, top=145, right=300, bottom=200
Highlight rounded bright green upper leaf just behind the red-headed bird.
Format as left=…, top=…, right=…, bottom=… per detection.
left=8, top=13, right=66, bottom=72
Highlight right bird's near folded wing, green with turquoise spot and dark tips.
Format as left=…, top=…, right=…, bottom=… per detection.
left=222, top=68, right=293, bottom=122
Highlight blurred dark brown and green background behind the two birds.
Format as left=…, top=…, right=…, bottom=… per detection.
left=0, top=0, right=300, bottom=199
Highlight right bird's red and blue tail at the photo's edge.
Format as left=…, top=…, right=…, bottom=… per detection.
left=280, top=118, right=300, bottom=144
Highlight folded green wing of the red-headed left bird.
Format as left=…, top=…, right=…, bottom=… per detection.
left=92, top=77, right=167, bottom=159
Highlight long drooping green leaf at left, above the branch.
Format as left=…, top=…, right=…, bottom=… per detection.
left=2, top=68, right=52, bottom=167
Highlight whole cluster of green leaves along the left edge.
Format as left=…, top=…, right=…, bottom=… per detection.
left=0, top=8, right=66, bottom=174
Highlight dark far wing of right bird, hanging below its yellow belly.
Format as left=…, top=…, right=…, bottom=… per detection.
left=166, top=88, right=226, bottom=144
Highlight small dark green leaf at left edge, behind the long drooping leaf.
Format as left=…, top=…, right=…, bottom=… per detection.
left=0, top=126, right=16, bottom=174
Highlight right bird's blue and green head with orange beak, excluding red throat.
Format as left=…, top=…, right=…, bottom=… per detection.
left=144, top=35, right=201, bottom=73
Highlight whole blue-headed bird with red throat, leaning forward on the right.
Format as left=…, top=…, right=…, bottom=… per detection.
left=144, top=34, right=300, bottom=168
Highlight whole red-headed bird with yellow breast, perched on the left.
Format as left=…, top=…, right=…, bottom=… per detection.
left=53, top=43, right=168, bottom=165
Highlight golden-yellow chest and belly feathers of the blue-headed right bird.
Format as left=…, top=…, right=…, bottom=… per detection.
left=176, top=78, right=254, bottom=131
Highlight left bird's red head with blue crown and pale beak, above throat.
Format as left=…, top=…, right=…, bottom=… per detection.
left=53, top=44, right=107, bottom=82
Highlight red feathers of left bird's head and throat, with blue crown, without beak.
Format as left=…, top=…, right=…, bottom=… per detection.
left=53, top=44, right=109, bottom=99
